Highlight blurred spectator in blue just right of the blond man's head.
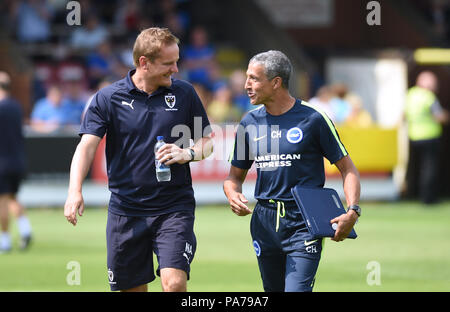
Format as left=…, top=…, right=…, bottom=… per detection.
left=182, top=26, right=217, bottom=89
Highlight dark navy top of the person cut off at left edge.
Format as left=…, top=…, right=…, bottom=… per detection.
left=0, top=97, right=25, bottom=176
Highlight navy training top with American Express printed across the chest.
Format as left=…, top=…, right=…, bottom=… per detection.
left=231, top=99, right=347, bottom=201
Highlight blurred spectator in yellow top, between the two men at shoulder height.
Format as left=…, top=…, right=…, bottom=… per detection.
left=207, top=84, right=242, bottom=123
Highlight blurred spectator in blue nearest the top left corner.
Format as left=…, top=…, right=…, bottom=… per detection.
left=12, top=0, right=52, bottom=43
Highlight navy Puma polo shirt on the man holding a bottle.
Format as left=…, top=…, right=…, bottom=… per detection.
left=80, top=70, right=210, bottom=216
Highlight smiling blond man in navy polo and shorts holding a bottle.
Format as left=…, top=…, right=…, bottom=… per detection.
left=64, top=27, right=212, bottom=291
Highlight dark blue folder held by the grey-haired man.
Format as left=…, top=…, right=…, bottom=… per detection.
left=291, top=185, right=357, bottom=239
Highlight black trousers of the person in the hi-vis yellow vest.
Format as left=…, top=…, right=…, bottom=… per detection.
left=406, top=139, right=440, bottom=204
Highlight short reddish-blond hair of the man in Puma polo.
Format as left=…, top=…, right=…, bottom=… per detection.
left=133, top=27, right=180, bottom=67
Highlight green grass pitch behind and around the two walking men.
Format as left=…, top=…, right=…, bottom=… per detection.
left=0, top=201, right=450, bottom=292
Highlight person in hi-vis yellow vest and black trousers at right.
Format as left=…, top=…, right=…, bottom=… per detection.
left=404, top=71, right=449, bottom=204
